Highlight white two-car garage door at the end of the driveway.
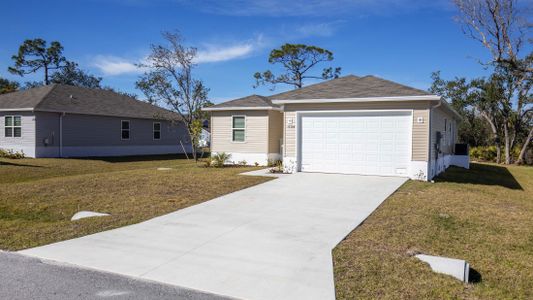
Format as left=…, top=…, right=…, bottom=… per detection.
left=300, top=112, right=412, bottom=176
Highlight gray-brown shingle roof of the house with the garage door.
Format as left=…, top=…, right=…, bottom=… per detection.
left=208, top=75, right=431, bottom=108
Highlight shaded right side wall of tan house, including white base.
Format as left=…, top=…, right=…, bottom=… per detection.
left=428, top=107, right=457, bottom=179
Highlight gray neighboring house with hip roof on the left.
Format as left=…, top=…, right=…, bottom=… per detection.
left=0, top=84, right=191, bottom=157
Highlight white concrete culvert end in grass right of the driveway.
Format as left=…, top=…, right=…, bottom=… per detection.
left=415, top=254, right=470, bottom=282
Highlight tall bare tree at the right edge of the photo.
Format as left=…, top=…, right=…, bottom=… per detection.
left=454, top=0, right=533, bottom=164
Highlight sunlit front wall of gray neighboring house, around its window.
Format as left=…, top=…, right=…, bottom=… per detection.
left=0, top=111, right=35, bottom=157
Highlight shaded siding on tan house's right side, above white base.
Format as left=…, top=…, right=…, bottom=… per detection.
left=430, top=107, right=457, bottom=160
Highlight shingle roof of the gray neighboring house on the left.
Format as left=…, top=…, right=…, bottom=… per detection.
left=0, top=84, right=178, bottom=119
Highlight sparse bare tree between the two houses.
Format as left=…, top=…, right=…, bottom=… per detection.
left=136, top=32, right=209, bottom=160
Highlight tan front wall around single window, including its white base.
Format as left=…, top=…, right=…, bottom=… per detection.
left=211, top=110, right=269, bottom=165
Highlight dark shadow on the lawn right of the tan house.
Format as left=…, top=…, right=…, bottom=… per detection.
left=435, top=163, right=523, bottom=190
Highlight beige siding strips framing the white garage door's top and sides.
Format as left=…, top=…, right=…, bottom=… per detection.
left=284, top=101, right=430, bottom=161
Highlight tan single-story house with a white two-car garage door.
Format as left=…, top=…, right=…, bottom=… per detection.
left=204, top=75, right=461, bottom=180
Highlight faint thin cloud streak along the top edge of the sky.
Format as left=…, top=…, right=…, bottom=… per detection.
left=178, top=0, right=450, bottom=17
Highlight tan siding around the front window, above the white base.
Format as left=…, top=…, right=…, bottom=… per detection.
left=211, top=110, right=268, bottom=153
